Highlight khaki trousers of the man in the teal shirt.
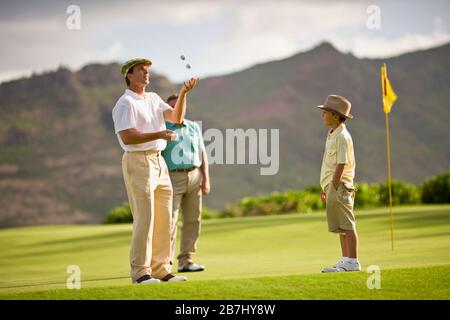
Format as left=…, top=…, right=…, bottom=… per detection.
left=169, top=169, right=202, bottom=267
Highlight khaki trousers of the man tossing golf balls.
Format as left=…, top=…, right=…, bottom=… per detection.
left=122, top=150, right=172, bottom=282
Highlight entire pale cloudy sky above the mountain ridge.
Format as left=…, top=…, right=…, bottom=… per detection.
left=0, top=0, right=450, bottom=81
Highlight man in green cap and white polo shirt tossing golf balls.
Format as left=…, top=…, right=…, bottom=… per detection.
left=112, top=59, right=198, bottom=284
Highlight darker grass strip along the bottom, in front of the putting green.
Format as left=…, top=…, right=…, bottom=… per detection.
left=1, top=266, right=450, bottom=300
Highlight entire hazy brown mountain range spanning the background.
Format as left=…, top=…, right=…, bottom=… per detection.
left=0, top=43, right=450, bottom=226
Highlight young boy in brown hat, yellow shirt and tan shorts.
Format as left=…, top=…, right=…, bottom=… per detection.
left=318, top=95, right=361, bottom=272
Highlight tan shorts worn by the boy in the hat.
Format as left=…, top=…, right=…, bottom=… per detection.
left=327, top=182, right=355, bottom=233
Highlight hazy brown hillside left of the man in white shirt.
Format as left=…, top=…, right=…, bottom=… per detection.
left=0, top=64, right=178, bottom=226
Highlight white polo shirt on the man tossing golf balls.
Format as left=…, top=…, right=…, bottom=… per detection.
left=112, top=89, right=172, bottom=151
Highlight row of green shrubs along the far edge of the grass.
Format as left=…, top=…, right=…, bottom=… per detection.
left=104, top=170, right=450, bottom=223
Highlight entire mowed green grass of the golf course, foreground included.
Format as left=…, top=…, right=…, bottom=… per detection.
left=0, top=205, right=450, bottom=299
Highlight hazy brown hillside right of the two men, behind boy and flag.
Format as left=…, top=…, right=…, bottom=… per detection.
left=186, top=43, right=450, bottom=208
